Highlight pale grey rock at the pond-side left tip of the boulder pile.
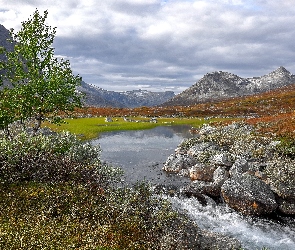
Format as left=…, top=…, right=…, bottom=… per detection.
left=163, top=154, right=196, bottom=173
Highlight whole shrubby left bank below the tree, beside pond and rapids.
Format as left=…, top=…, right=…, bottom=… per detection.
left=0, top=129, right=197, bottom=249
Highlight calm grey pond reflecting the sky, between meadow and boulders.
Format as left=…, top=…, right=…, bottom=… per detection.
left=92, top=126, right=190, bottom=186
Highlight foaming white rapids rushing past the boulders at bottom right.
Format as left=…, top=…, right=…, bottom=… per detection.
left=169, top=197, right=295, bottom=250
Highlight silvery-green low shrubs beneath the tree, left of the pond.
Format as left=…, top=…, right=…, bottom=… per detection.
left=0, top=129, right=122, bottom=185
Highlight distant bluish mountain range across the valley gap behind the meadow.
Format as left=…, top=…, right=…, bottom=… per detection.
left=78, top=81, right=175, bottom=108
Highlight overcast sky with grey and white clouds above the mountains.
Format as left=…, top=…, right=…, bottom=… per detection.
left=0, top=0, right=295, bottom=93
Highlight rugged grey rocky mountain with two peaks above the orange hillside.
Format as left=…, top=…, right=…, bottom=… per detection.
left=163, top=66, right=295, bottom=106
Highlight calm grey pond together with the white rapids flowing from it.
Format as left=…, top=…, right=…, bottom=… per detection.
left=92, top=126, right=295, bottom=250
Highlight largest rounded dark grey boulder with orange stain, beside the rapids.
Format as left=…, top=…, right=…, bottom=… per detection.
left=221, top=173, right=278, bottom=215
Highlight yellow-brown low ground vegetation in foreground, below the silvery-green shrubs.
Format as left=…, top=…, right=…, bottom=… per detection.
left=0, top=183, right=196, bottom=249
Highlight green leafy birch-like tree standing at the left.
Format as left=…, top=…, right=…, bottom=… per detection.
left=0, top=9, right=81, bottom=131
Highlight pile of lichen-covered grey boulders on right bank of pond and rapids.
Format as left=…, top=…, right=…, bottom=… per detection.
left=163, top=123, right=295, bottom=249
